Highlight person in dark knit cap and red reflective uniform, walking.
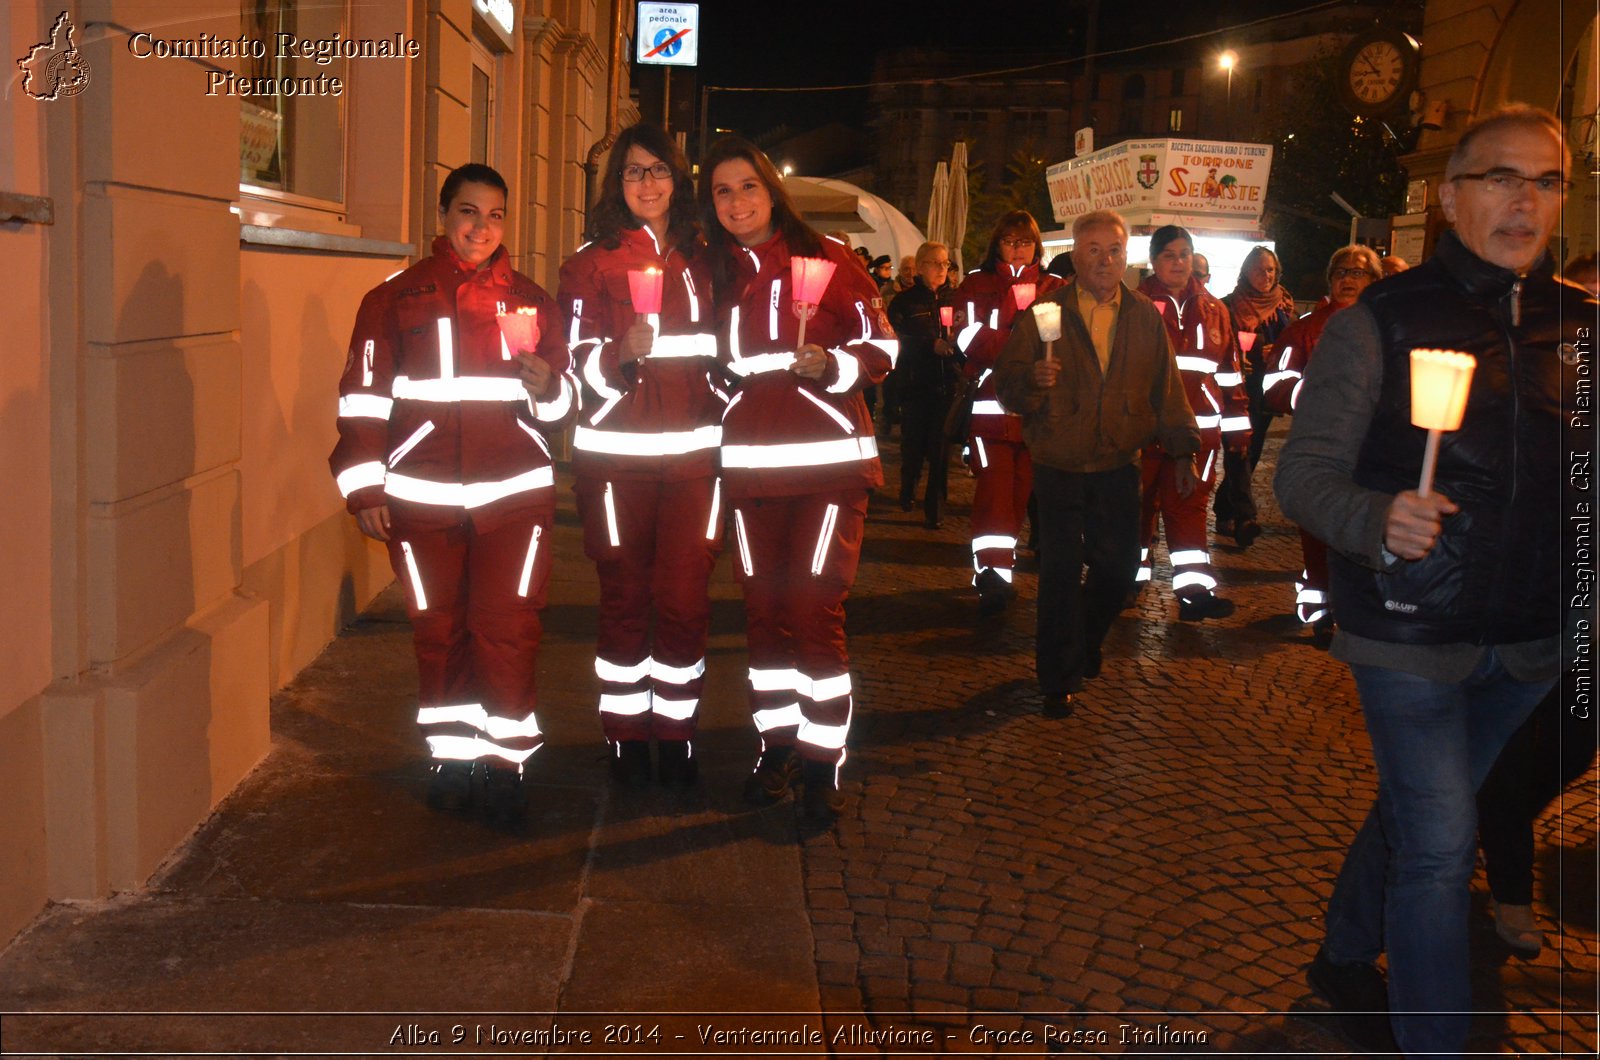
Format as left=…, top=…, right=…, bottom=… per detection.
left=1139, top=224, right=1250, bottom=621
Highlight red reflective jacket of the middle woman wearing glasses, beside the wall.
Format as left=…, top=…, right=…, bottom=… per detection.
left=558, top=227, right=728, bottom=480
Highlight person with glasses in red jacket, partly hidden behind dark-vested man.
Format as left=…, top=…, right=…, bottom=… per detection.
left=1262, top=243, right=1384, bottom=645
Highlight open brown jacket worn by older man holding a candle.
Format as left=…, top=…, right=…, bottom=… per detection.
left=994, top=285, right=1200, bottom=472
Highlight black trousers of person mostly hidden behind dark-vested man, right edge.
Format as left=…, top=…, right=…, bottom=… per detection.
left=1478, top=668, right=1600, bottom=905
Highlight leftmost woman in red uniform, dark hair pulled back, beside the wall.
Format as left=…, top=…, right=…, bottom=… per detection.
left=328, top=163, right=578, bottom=818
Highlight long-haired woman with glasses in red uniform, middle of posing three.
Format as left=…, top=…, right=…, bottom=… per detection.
left=558, top=125, right=726, bottom=788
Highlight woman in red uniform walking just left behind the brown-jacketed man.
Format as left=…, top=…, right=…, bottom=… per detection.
left=957, top=210, right=1061, bottom=615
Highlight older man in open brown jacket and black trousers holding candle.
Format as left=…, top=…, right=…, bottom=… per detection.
left=995, top=210, right=1200, bottom=717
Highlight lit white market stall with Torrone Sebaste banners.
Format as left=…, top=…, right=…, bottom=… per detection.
left=1045, top=138, right=1272, bottom=298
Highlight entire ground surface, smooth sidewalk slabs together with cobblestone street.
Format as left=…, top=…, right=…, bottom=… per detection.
left=0, top=445, right=1600, bottom=1055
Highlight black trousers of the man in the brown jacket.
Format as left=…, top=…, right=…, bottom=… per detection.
left=1034, top=464, right=1139, bottom=697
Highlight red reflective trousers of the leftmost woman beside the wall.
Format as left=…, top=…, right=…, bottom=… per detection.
left=389, top=506, right=555, bottom=765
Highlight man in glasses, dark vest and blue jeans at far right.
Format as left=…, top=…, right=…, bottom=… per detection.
left=1275, top=106, right=1595, bottom=1055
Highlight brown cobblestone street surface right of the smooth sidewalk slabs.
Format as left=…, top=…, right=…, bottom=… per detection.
left=805, top=439, right=1597, bottom=1055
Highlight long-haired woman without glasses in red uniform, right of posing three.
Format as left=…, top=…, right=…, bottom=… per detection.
left=699, top=138, right=891, bottom=821
